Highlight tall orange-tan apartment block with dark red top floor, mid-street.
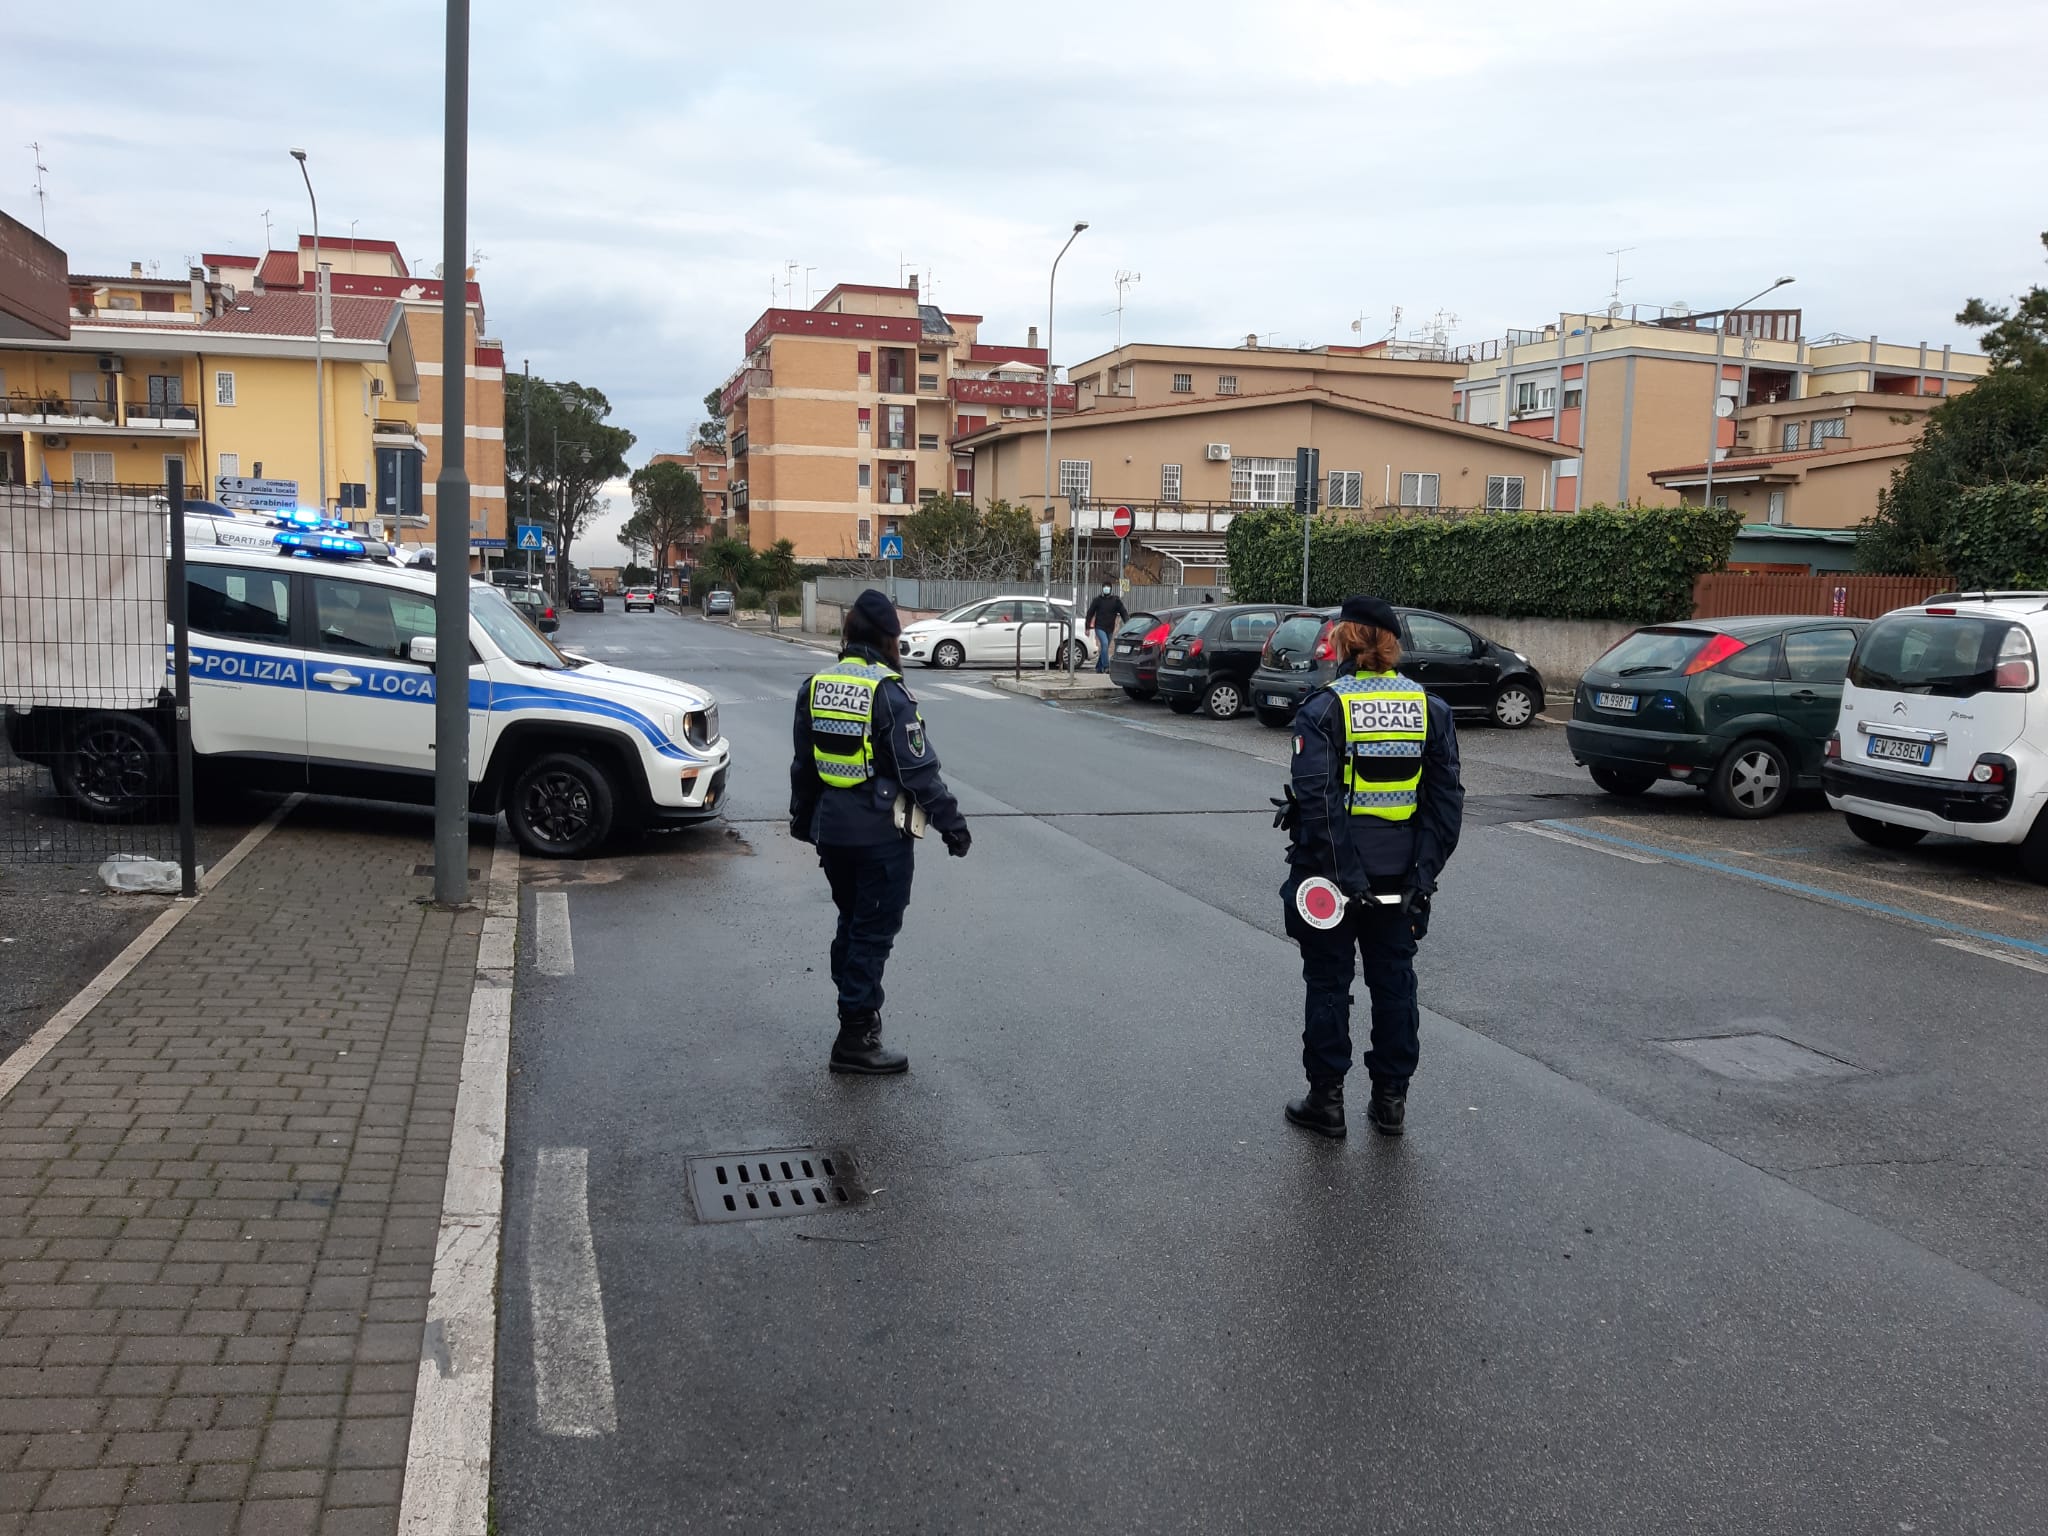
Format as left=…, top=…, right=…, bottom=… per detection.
left=721, top=276, right=1075, bottom=559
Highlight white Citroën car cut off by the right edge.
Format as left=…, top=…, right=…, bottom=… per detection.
left=1821, top=592, right=2048, bottom=881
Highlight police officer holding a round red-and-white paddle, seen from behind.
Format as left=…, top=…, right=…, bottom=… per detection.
left=1280, top=596, right=1464, bottom=1137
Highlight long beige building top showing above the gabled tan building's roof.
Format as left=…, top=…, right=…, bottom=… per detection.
left=1067, top=336, right=1464, bottom=416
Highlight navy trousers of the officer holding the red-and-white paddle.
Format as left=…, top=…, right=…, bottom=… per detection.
left=1280, top=870, right=1421, bottom=1087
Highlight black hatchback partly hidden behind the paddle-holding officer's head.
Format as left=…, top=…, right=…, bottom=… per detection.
left=1251, top=608, right=1542, bottom=731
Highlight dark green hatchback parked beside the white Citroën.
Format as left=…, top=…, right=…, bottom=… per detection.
left=1565, top=614, right=1864, bottom=817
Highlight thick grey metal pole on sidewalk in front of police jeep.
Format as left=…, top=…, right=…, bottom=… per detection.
left=434, top=0, right=469, bottom=907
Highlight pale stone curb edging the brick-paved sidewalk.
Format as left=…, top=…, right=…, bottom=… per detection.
left=397, top=842, right=520, bottom=1536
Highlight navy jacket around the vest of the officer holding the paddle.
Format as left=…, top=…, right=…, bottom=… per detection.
left=1286, top=688, right=1464, bottom=895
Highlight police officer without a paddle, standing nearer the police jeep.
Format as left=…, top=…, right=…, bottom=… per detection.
left=788, top=588, right=973, bottom=1075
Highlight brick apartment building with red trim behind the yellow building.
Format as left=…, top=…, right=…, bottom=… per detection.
left=203, top=236, right=510, bottom=563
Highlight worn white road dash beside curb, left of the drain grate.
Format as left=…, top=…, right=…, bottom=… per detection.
left=526, top=1147, right=618, bottom=1440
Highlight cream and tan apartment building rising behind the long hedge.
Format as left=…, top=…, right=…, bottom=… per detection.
left=1450, top=305, right=1989, bottom=514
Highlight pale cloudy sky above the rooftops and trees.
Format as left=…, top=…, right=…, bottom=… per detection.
left=0, top=0, right=2048, bottom=557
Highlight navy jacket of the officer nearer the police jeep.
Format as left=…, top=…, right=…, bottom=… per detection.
left=788, top=645, right=967, bottom=848
